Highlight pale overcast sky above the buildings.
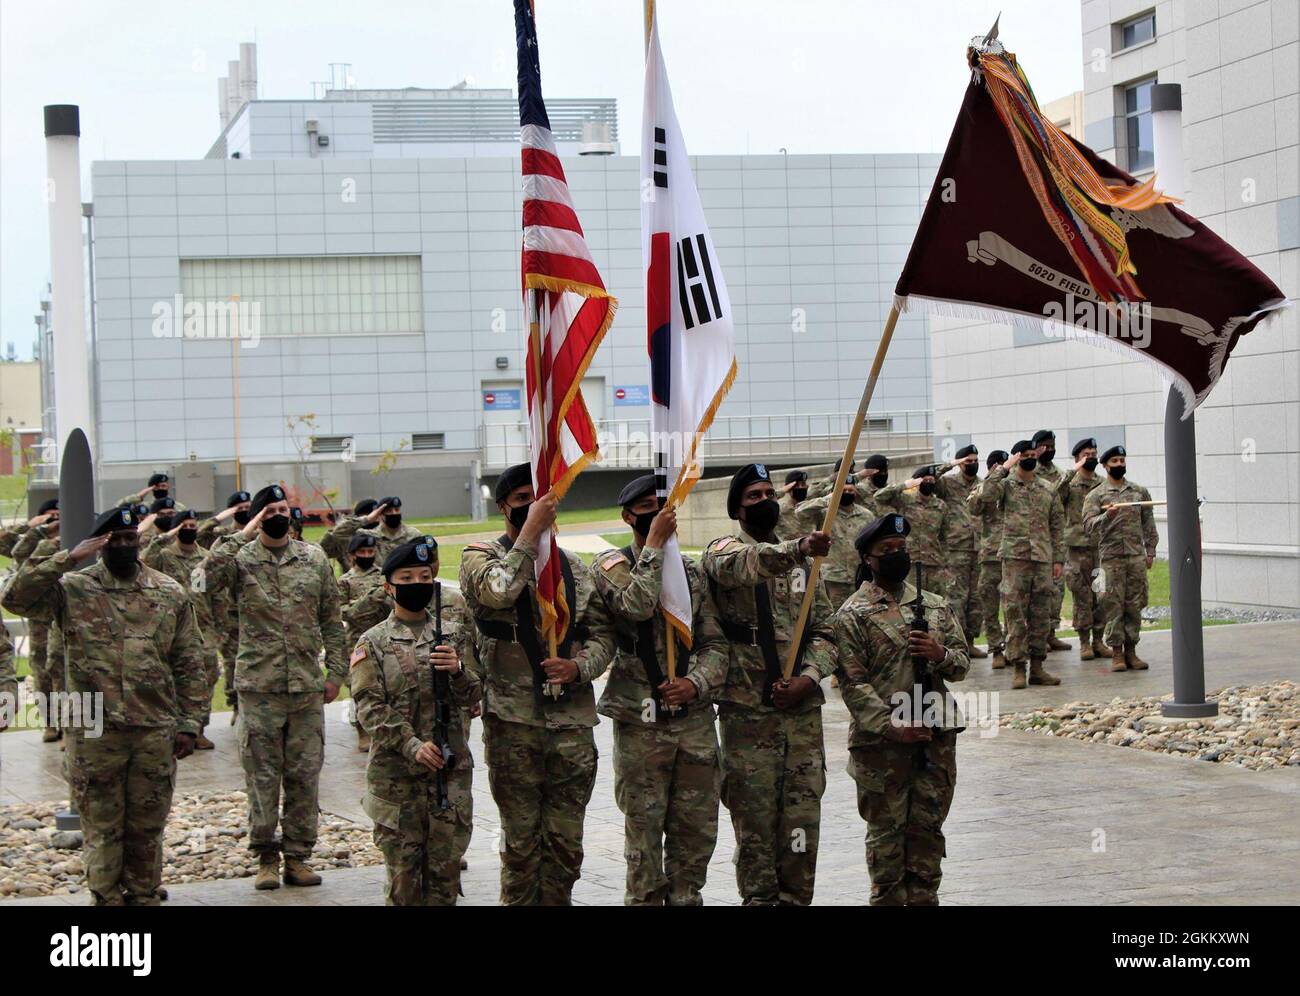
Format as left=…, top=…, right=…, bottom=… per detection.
left=0, top=0, right=1083, bottom=359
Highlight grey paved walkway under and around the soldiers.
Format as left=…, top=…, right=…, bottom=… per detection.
left=0, top=623, right=1300, bottom=906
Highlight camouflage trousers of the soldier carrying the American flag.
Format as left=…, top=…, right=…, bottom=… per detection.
left=484, top=715, right=597, bottom=906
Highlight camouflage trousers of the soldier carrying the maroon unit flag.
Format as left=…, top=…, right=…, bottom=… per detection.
left=720, top=709, right=826, bottom=906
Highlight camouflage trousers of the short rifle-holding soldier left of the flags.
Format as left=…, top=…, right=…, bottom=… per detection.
left=364, top=757, right=475, bottom=906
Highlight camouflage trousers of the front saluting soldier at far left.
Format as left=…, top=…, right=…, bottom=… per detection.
left=68, top=727, right=176, bottom=906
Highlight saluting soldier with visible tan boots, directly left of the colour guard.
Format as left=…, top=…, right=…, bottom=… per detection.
left=204, top=484, right=347, bottom=889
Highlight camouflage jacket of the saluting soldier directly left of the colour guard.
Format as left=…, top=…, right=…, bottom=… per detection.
left=204, top=532, right=347, bottom=692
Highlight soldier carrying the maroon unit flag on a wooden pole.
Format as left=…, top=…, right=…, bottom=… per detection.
left=703, top=464, right=835, bottom=906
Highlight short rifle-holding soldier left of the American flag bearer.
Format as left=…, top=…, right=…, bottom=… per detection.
left=348, top=537, right=482, bottom=906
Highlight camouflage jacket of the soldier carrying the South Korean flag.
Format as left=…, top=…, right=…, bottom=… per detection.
left=592, top=538, right=728, bottom=722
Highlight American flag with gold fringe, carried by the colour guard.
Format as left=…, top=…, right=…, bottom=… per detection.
left=515, top=0, right=619, bottom=641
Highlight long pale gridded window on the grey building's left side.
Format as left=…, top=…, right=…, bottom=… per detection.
left=181, top=256, right=424, bottom=335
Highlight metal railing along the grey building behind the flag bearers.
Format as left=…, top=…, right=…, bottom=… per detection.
left=478, top=410, right=933, bottom=472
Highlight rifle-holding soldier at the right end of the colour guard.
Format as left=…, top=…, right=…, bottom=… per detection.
left=835, top=515, right=970, bottom=906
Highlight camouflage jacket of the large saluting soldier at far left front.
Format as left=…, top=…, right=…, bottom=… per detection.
left=4, top=550, right=208, bottom=733
